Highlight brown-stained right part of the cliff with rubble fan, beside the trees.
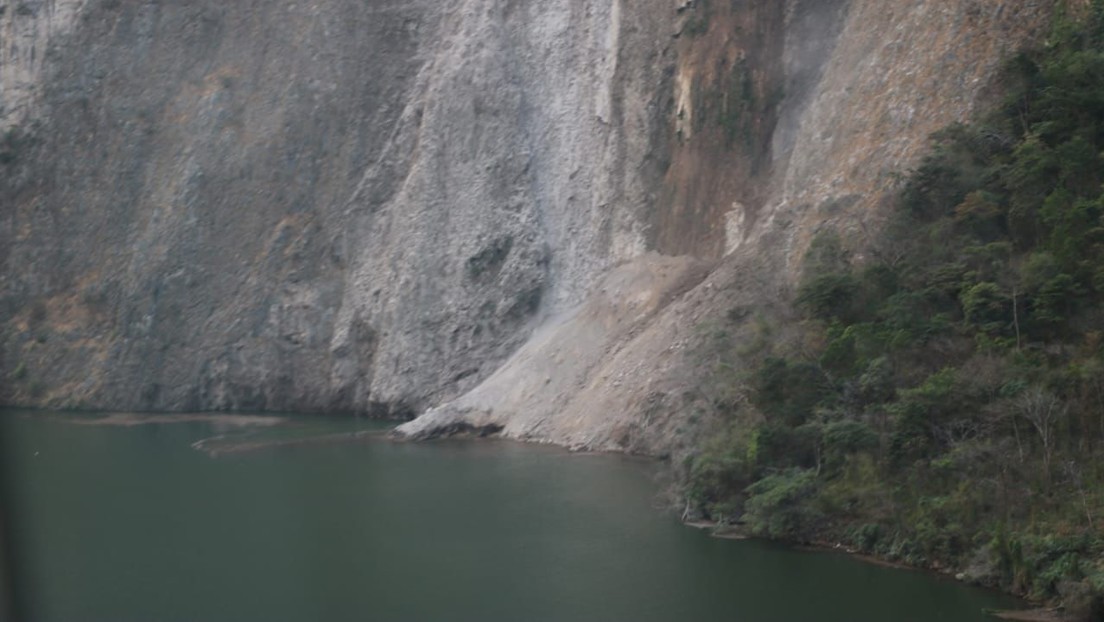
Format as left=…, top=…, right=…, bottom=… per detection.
left=399, top=0, right=1054, bottom=454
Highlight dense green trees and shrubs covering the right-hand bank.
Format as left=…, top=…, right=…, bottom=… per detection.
left=686, top=7, right=1104, bottom=619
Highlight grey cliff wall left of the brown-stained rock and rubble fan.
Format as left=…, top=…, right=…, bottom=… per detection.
left=0, top=0, right=668, bottom=414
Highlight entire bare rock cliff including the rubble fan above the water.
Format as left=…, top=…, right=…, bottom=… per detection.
left=0, top=0, right=1053, bottom=452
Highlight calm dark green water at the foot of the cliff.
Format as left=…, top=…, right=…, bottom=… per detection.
left=0, top=411, right=1016, bottom=622
